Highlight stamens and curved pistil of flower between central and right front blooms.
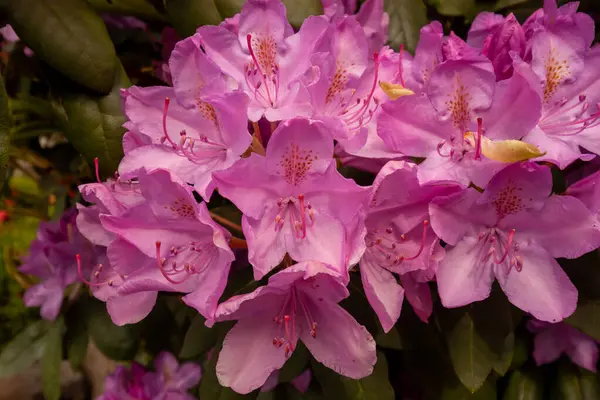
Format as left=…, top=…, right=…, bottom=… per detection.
left=366, top=220, right=429, bottom=268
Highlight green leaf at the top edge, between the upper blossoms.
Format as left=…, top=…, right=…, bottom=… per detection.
left=384, top=0, right=428, bottom=53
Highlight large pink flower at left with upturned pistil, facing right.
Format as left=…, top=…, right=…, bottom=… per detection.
left=98, top=169, right=234, bottom=318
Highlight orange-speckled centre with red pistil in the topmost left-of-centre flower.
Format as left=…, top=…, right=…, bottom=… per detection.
left=244, top=34, right=280, bottom=108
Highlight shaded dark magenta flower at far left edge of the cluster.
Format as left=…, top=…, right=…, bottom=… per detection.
left=19, top=209, right=102, bottom=321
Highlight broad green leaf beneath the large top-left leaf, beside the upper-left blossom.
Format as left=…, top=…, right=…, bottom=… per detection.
left=63, top=64, right=129, bottom=176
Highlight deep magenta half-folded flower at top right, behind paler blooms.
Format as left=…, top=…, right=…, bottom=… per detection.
left=467, top=13, right=526, bottom=81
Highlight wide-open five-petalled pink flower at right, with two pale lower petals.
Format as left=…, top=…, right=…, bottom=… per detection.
left=429, top=163, right=600, bottom=322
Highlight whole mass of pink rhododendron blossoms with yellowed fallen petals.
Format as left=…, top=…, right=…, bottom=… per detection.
left=17, top=0, right=600, bottom=398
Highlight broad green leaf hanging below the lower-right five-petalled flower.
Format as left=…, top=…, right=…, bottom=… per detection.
left=440, top=291, right=514, bottom=392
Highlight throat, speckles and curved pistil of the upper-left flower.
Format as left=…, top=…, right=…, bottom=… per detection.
left=161, top=97, right=227, bottom=165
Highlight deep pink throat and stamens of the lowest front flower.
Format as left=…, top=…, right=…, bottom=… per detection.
left=273, top=285, right=317, bottom=357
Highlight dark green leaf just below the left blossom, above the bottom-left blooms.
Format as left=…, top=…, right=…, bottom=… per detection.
left=85, top=299, right=140, bottom=360
